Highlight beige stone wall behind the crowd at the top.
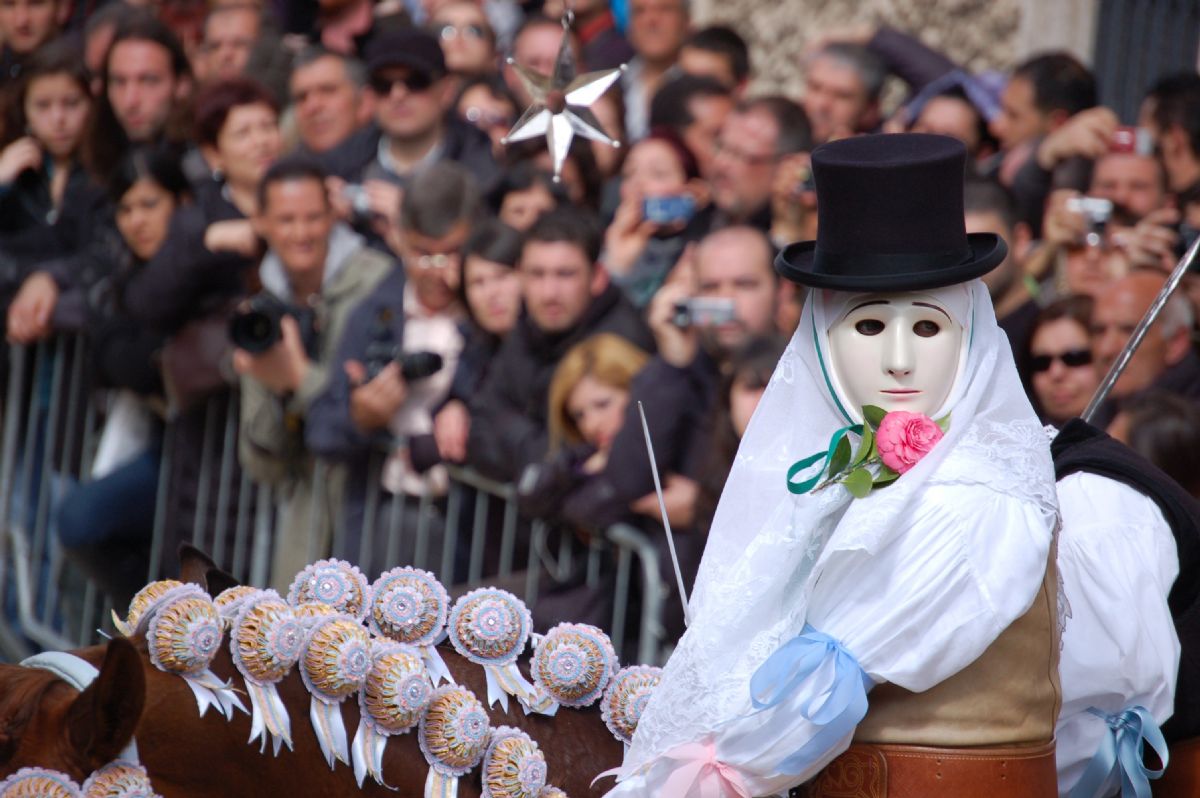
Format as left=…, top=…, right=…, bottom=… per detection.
left=692, top=0, right=1098, bottom=102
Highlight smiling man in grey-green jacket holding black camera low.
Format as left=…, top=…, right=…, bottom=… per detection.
left=229, top=157, right=396, bottom=587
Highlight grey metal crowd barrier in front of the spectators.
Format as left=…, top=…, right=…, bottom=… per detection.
left=0, top=335, right=671, bottom=664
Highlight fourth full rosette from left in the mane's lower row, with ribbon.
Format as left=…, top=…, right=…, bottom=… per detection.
left=350, top=641, right=433, bottom=787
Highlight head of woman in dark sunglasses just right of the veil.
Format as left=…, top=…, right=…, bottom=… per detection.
left=1028, top=295, right=1102, bottom=426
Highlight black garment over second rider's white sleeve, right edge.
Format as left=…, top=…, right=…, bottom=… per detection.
left=1050, top=419, right=1200, bottom=742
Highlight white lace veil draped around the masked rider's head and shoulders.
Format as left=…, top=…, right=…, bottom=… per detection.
left=620, top=280, right=1056, bottom=794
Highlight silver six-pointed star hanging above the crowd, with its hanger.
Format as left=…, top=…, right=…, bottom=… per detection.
left=500, top=10, right=625, bottom=182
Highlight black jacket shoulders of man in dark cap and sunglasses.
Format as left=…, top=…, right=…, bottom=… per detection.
left=320, top=115, right=499, bottom=191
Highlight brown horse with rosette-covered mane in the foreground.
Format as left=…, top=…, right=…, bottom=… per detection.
left=0, top=557, right=622, bottom=798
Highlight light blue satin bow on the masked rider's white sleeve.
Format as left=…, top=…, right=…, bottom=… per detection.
left=750, top=624, right=875, bottom=774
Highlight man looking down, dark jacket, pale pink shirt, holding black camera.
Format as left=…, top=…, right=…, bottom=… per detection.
left=305, top=161, right=480, bottom=568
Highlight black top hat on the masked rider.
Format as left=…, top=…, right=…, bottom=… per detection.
left=775, top=133, right=1008, bottom=292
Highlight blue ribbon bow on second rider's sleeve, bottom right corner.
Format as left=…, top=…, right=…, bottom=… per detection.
left=1068, top=707, right=1168, bottom=798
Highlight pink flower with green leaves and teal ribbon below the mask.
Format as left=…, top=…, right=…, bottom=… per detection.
left=787, top=404, right=950, bottom=499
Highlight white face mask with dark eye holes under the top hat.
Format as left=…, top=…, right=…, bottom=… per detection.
left=828, top=293, right=964, bottom=416
